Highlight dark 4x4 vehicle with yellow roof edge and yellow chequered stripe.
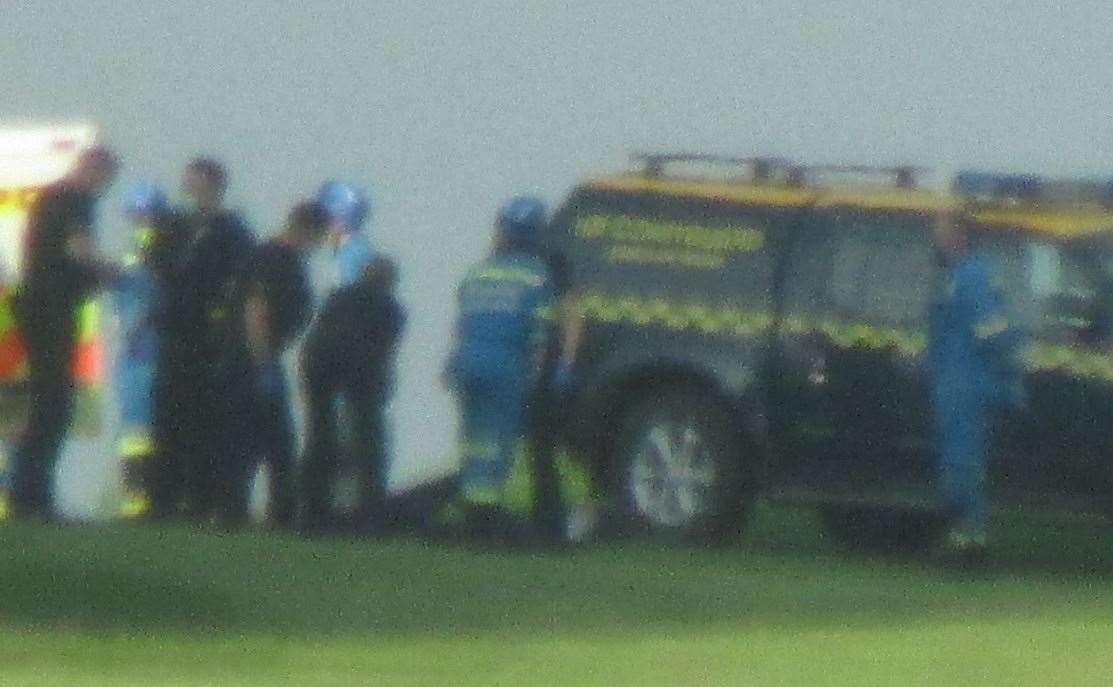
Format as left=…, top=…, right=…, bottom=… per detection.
left=550, top=156, right=1113, bottom=538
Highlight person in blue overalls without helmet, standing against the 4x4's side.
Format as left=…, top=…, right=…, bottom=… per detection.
left=928, top=215, right=1023, bottom=560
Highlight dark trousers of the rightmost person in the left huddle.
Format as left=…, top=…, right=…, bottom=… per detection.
left=302, top=372, right=387, bottom=527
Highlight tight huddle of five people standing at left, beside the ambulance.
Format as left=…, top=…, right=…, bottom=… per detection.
left=11, top=147, right=405, bottom=528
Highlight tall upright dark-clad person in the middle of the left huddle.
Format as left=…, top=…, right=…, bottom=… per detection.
left=151, top=158, right=255, bottom=518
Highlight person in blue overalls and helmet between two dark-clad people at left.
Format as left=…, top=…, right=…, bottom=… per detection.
left=112, top=181, right=171, bottom=518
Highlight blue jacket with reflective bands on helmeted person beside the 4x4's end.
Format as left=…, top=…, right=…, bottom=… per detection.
left=450, top=254, right=553, bottom=384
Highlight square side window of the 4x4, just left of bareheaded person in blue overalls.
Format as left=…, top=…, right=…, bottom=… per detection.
left=828, top=218, right=935, bottom=326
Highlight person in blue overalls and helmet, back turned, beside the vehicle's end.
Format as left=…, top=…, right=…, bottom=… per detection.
left=446, top=196, right=553, bottom=539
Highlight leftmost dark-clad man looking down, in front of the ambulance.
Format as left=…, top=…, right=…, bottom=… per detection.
left=12, top=147, right=118, bottom=519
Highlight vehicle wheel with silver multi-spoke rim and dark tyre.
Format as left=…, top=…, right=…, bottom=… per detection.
left=614, top=390, right=751, bottom=542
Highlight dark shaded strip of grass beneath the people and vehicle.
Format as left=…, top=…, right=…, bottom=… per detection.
left=0, top=498, right=1113, bottom=637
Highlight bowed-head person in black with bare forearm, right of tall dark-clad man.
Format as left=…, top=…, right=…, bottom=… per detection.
left=220, top=198, right=328, bottom=527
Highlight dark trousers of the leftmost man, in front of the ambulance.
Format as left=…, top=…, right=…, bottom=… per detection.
left=12, top=313, right=77, bottom=517
